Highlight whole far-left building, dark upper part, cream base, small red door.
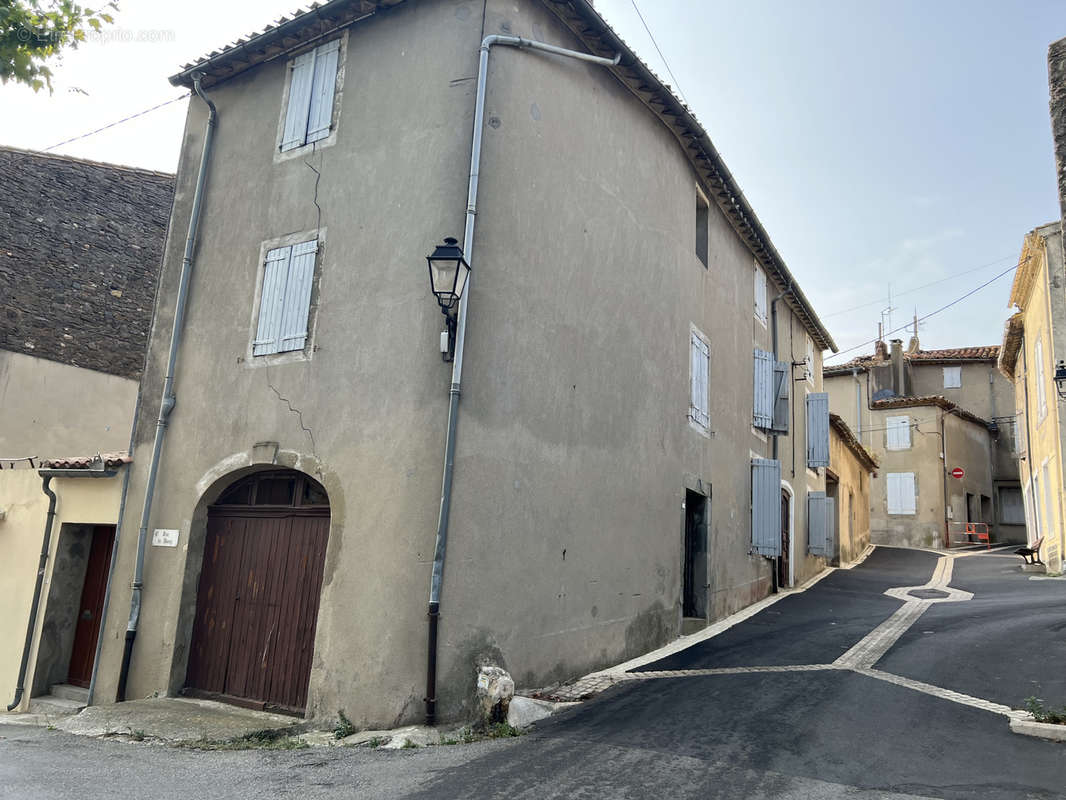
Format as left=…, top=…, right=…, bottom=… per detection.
left=0, top=147, right=174, bottom=709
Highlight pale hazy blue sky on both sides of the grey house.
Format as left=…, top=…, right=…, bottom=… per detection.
left=0, top=0, right=1066, bottom=362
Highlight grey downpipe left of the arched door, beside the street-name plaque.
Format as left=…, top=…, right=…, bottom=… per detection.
left=116, top=75, right=217, bottom=702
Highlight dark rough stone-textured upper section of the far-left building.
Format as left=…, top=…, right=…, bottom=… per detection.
left=0, top=147, right=174, bottom=378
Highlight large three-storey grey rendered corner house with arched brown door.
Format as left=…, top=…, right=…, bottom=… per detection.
left=91, top=0, right=835, bottom=726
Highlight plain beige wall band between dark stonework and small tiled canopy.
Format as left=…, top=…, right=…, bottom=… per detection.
left=0, top=350, right=138, bottom=458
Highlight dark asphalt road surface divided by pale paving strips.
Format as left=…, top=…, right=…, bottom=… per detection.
left=0, top=548, right=1066, bottom=800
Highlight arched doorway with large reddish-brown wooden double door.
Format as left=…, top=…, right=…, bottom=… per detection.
left=185, top=469, right=329, bottom=713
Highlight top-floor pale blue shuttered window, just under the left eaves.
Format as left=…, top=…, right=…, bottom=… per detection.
left=281, top=38, right=340, bottom=150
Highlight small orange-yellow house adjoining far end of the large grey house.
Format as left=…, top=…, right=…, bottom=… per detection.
left=825, top=414, right=877, bottom=565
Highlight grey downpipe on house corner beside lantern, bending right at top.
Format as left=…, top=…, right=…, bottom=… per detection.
left=424, top=34, right=621, bottom=725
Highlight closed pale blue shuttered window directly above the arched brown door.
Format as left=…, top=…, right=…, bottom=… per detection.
left=252, top=240, right=318, bottom=355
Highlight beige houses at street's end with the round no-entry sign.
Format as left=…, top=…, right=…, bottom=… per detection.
left=825, top=336, right=1025, bottom=547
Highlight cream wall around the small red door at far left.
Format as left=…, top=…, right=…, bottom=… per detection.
left=0, top=469, right=123, bottom=710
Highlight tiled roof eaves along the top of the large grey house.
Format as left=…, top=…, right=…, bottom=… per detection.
left=171, top=0, right=837, bottom=352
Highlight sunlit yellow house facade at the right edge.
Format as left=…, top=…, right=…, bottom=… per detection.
left=1000, top=222, right=1066, bottom=573
